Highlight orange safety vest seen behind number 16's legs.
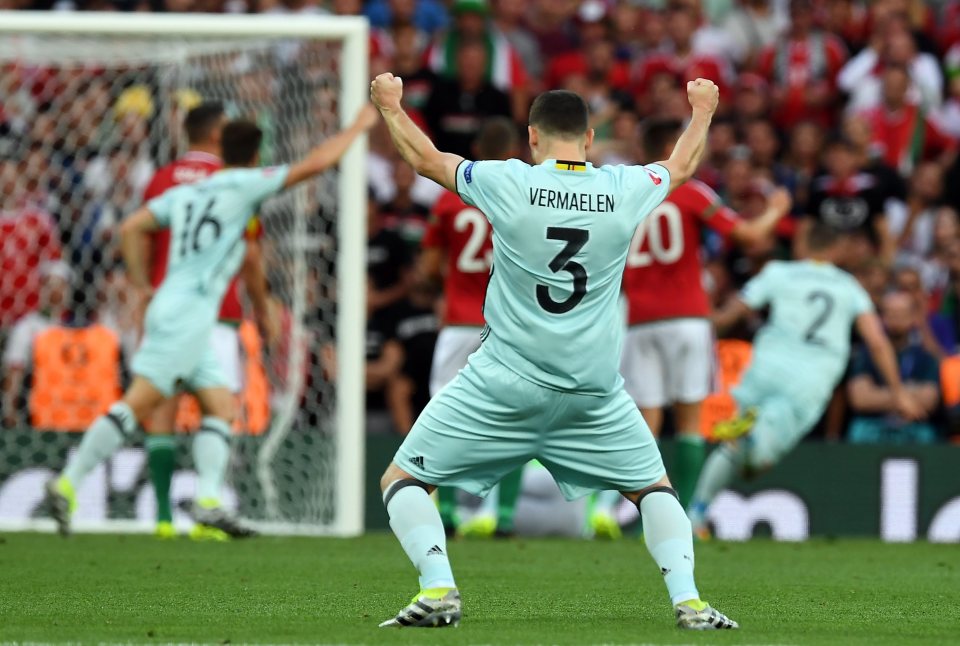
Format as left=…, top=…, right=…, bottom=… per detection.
left=176, top=321, right=270, bottom=435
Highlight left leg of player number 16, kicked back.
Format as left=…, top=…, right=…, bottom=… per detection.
left=46, top=375, right=172, bottom=535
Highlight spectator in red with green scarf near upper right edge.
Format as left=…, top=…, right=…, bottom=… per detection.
left=865, top=65, right=956, bottom=177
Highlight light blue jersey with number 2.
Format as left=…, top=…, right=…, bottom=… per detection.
left=741, top=260, right=873, bottom=392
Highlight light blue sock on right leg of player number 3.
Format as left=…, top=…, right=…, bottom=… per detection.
left=640, top=491, right=700, bottom=605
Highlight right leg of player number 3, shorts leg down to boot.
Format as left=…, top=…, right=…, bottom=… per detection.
left=540, top=391, right=736, bottom=629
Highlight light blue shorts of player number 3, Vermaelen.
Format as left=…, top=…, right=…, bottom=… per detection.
left=393, top=347, right=666, bottom=500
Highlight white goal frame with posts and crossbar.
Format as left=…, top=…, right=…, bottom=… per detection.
left=0, top=11, right=370, bottom=537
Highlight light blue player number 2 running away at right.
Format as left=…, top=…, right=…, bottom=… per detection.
left=688, top=221, right=923, bottom=538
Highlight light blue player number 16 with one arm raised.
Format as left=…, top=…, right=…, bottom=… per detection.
left=46, top=105, right=376, bottom=534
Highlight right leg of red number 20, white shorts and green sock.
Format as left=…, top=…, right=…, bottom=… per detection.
left=660, top=319, right=713, bottom=507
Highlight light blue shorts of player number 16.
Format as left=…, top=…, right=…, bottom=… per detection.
left=130, top=295, right=229, bottom=397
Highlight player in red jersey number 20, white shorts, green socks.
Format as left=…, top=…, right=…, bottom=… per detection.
left=621, top=121, right=791, bottom=506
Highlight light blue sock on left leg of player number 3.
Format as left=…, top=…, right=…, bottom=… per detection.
left=383, top=480, right=457, bottom=590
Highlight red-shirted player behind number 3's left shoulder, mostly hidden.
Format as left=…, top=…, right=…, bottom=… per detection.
left=419, top=118, right=521, bottom=535
